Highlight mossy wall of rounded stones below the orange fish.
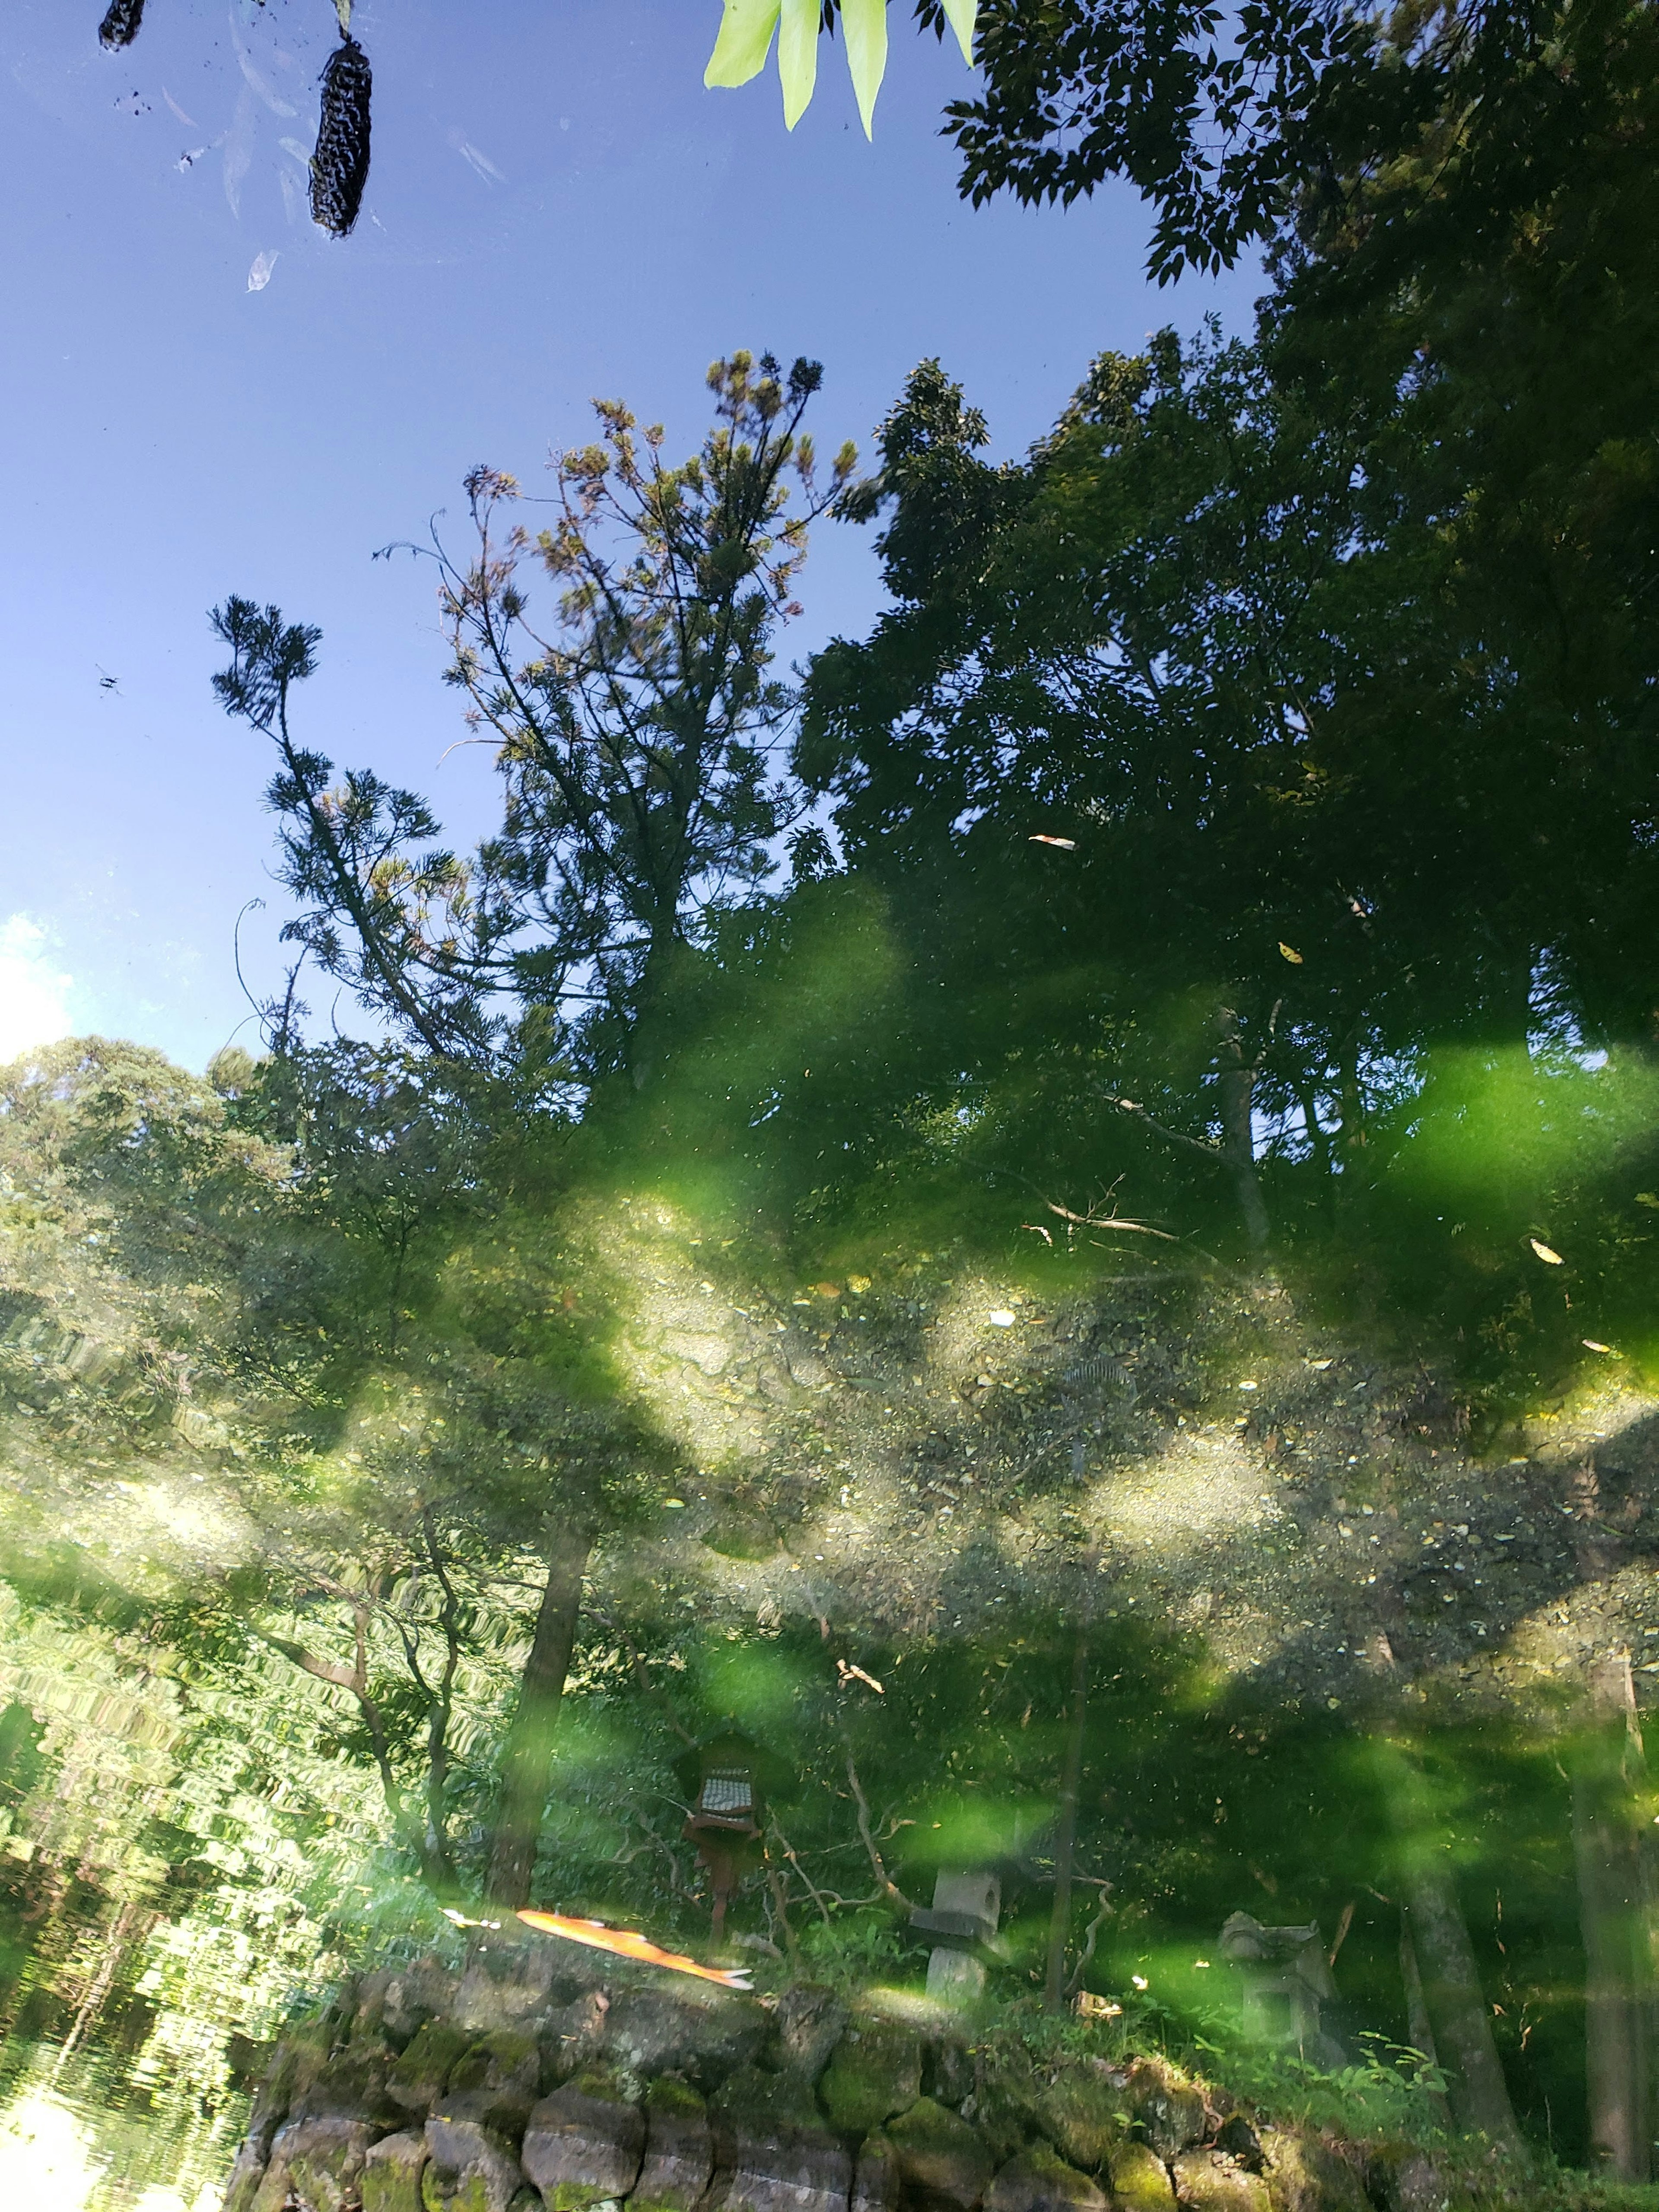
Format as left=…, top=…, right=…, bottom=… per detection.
left=226, top=1931, right=1380, bottom=2212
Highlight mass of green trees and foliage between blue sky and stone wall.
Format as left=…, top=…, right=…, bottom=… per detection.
left=0, top=0, right=1659, bottom=2179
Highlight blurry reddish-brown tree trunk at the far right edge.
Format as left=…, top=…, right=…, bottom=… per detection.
left=1573, top=1653, right=1653, bottom=2181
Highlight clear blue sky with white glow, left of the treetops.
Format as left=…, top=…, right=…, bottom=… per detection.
left=0, top=0, right=1256, bottom=1066
